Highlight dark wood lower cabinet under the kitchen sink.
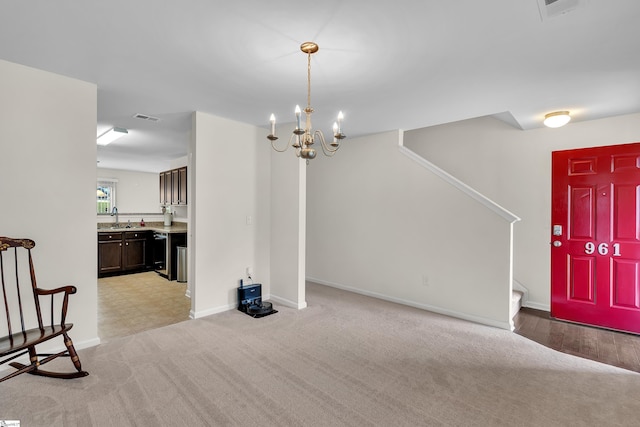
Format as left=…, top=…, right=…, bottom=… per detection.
left=98, top=231, right=151, bottom=276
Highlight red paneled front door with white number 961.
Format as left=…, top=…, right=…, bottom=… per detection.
left=551, top=143, right=640, bottom=333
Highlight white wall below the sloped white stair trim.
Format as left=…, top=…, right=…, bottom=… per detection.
left=307, top=132, right=511, bottom=328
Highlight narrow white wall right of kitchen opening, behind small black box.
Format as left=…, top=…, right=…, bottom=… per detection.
left=188, top=112, right=271, bottom=318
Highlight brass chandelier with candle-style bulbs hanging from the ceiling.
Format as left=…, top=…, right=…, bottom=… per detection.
left=267, top=42, right=346, bottom=163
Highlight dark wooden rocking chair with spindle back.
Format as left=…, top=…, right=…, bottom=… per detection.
left=0, top=237, right=89, bottom=382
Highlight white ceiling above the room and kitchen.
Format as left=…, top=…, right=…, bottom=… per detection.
left=0, top=0, right=640, bottom=172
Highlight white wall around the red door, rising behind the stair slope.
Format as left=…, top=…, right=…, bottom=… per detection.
left=404, top=114, right=640, bottom=310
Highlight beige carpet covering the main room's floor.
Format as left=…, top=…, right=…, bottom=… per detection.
left=0, top=285, right=640, bottom=427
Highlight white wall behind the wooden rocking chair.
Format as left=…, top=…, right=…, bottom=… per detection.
left=0, top=60, right=99, bottom=349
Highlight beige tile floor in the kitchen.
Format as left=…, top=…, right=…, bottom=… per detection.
left=98, top=271, right=191, bottom=341
